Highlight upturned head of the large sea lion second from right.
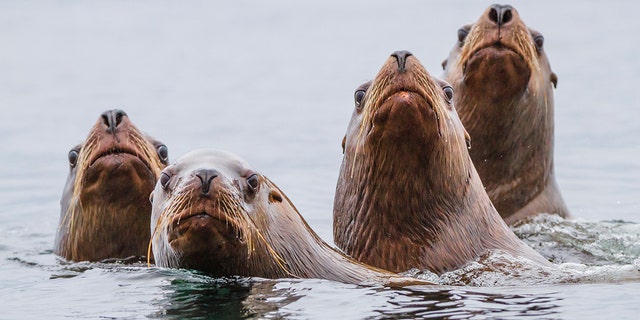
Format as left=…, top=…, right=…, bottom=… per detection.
left=343, top=51, right=469, bottom=189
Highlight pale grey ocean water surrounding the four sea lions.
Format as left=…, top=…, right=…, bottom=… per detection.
left=0, top=0, right=640, bottom=319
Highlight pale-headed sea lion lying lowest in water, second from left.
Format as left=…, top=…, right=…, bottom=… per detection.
left=151, top=149, right=427, bottom=285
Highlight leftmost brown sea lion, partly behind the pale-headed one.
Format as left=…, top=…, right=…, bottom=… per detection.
left=54, top=110, right=168, bottom=261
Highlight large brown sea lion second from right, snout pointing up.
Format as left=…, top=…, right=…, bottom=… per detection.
left=333, top=51, right=548, bottom=273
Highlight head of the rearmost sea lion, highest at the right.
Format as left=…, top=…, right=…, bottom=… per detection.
left=443, top=5, right=557, bottom=107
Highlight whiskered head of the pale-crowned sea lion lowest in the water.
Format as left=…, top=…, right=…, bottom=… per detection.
left=151, top=150, right=282, bottom=276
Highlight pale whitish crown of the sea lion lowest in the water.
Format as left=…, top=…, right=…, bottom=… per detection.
left=174, top=149, right=252, bottom=177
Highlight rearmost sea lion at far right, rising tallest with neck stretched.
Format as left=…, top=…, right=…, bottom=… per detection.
left=443, top=4, right=569, bottom=224
